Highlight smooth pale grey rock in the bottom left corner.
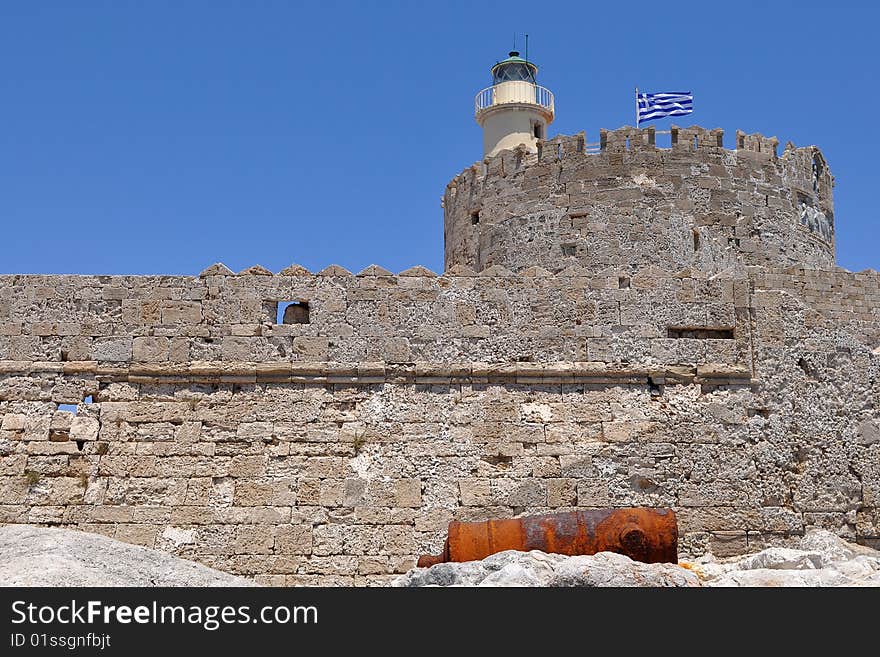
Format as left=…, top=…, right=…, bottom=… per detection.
left=0, top=525, right=253, bottom=586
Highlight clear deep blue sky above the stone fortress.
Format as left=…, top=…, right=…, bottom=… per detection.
left=0, top=0, right=880, bottom=274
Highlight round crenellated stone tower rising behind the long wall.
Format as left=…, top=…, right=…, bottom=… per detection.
left=443, top=127, right=834, bottom=272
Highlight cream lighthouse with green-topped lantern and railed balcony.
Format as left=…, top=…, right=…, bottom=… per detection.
left=474, top=50, right=555, bottom=157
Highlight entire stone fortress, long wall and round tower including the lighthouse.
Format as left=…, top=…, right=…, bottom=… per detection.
left=0, top=54, right=880, bottom=585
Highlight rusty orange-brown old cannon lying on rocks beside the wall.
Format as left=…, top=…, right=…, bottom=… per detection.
left=418, top=508, right=678, bottom=567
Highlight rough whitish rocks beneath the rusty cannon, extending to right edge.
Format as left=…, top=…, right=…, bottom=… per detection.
left=392, top=530, right=880, bottom=586
